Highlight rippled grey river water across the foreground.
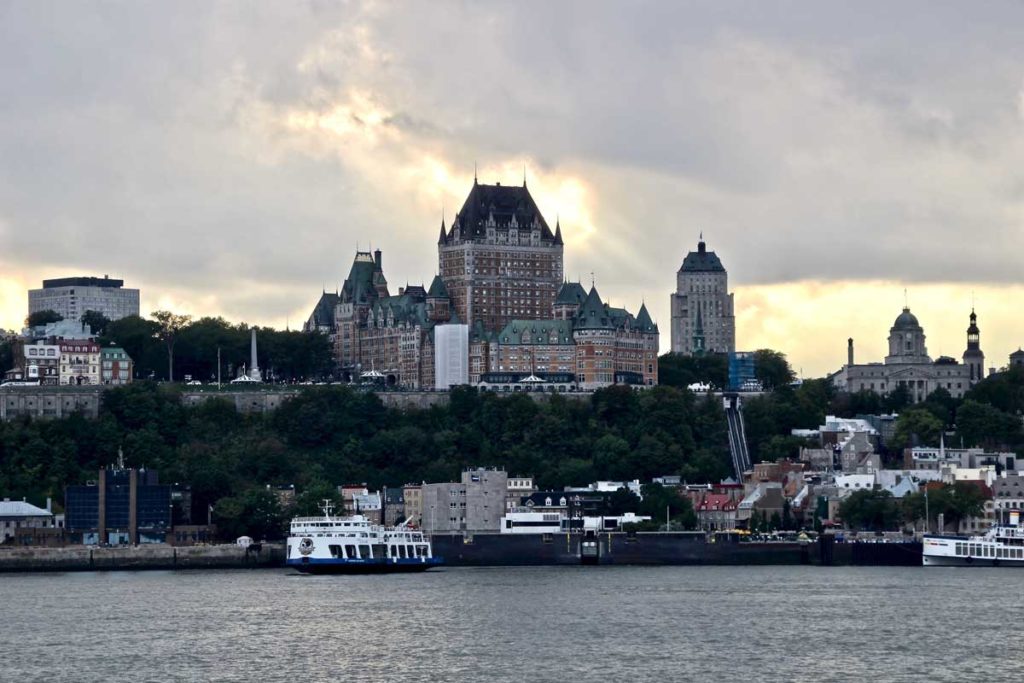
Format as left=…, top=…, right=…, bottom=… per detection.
left=0, top=567, right=1024, bottom=682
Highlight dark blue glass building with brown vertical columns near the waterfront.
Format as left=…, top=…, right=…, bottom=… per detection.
left=65, top=467, right=172, bottom=546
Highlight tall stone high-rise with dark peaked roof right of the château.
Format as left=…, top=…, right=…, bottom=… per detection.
left=671, top=236, right=736, bottom=355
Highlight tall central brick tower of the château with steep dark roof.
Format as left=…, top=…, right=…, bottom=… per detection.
left=437, top=178, right=563, bottom=331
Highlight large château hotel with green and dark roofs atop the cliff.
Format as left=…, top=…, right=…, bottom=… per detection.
left=304, top=179, right=658, bottom=390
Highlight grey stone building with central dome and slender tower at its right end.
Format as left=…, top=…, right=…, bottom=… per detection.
left=828, top=307, right=985, bottom=402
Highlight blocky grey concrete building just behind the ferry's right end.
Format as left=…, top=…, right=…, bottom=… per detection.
left=422, top=467, right=508, bottom=533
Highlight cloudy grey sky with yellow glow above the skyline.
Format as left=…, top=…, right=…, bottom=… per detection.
left=0, top=0, right=1024, bottom=377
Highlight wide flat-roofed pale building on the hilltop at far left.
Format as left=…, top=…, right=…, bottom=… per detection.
left=29, top=275, right=138, bottom=321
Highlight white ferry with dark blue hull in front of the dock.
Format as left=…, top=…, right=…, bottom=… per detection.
left=285, top=501, right=444, bottom=573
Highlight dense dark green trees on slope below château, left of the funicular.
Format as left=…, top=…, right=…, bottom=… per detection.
left=0, top=382, right=730, bottom=536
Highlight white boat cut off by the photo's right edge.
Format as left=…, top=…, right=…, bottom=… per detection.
left=921, top=510, right=1024, bottom=567
